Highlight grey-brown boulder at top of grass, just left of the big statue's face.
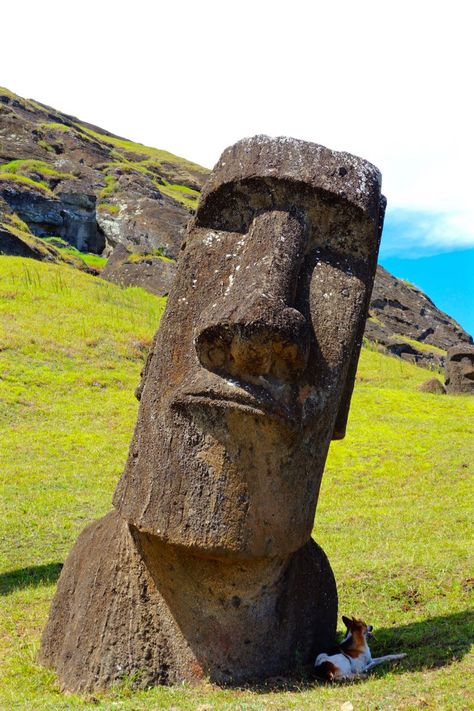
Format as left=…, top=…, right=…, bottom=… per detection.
left=101, top=244, right=176, bottom=296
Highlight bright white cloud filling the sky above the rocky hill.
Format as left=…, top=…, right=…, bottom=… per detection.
left=0, top=0, right=474, bottom=256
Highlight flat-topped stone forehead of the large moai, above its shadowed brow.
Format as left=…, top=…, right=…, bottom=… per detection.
left=201, top=135, right=382, bottom=217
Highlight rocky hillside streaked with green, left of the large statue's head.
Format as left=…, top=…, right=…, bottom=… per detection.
left=0, top=88, right=208, bottom=256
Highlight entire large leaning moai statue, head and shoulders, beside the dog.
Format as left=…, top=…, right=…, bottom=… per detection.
left=41, top=136, right=384, bottom=690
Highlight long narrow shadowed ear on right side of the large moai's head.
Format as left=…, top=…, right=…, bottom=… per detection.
left=332, top=195, right=387, bottom=439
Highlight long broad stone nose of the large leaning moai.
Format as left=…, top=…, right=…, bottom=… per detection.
left=195, top=210, right=309, bottom=381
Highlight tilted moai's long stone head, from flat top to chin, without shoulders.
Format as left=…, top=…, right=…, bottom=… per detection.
left=114, top=136, right=384, bottom=558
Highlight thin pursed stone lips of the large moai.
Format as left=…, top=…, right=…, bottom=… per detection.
left=175, top=381, right=301, bottom=426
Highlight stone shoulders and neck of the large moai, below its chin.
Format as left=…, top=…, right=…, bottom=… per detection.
left=40, top=512, right=337, bottom=691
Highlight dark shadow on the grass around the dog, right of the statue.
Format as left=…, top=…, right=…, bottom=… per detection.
left=245, top=610, right=474, bottom=693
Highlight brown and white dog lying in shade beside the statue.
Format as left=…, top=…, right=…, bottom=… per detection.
left=314, top=615, right=407, bottom=681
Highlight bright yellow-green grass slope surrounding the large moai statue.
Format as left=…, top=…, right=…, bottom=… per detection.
left=0, top=257, right=474, bottom=711
